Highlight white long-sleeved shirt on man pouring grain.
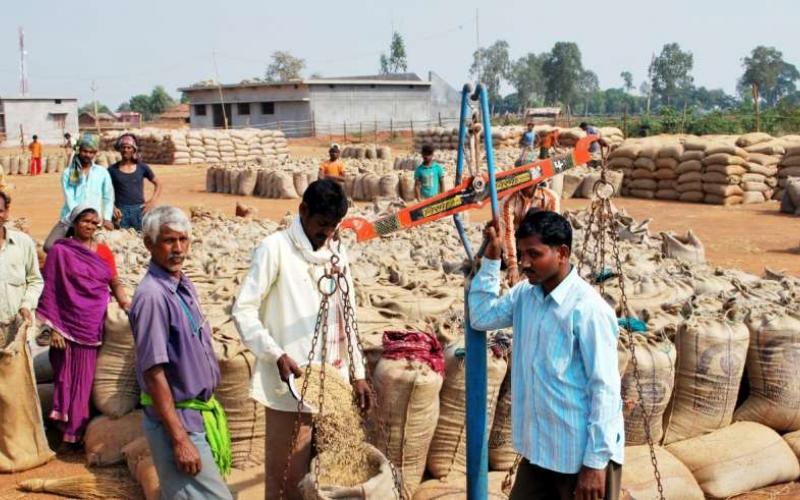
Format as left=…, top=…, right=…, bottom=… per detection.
left=231, top=221, right=365, bottom=412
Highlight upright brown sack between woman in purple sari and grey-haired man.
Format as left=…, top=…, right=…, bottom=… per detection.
left=92, top=302, right=139, bottom=417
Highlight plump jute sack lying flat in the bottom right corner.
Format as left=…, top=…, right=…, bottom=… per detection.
left=667, top=422, right=800, bottom=498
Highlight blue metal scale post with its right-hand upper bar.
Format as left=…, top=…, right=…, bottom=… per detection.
left=464, top=84, right=500, bottom=500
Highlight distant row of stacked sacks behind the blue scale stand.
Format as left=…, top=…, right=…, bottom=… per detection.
left=414, top=125, right=624, bottom=151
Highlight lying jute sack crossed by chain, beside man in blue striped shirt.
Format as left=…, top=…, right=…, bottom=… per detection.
left=622, top=445, right=705, bottom=500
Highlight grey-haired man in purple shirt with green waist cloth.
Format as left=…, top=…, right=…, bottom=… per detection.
left=130, top=206, right=232, bottom=499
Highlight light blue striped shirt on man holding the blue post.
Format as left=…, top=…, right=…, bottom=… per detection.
left=469, top=258, right=625, bottom=474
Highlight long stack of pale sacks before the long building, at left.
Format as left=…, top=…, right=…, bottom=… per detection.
left=101, top=128, right=289, bottom=165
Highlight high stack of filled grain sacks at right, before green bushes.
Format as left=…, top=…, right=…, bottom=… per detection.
left=608, top=133, right=800, bottom=205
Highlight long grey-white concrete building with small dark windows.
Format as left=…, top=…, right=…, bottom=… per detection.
left=179, top=72, right=460, bottom=136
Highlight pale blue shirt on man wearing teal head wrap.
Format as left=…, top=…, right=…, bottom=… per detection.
left=61, top=164, right=114, bottom=220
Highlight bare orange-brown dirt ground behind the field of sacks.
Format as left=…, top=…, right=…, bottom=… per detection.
left=7, top=164, right=800, bottom=276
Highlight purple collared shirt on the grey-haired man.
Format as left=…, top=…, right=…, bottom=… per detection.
left=129, top=262, right=220, bottom=432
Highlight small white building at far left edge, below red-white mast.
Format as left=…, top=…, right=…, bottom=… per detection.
left=0, top=96, right=78, bottom=147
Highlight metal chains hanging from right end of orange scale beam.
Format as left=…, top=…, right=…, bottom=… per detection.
left=578, top=146, right=664, bottom=500
